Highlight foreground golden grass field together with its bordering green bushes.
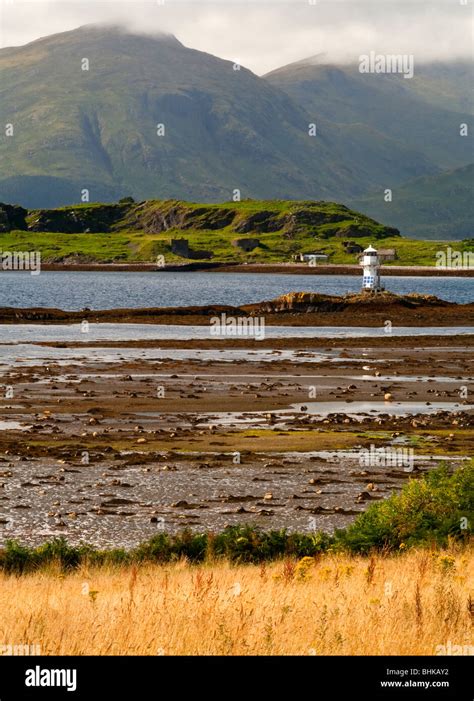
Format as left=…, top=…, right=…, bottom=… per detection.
left=0, top=452, right=474, bottom=655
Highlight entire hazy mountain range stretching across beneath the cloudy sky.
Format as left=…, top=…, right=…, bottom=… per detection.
left=0, top=25, right=473, bottom=235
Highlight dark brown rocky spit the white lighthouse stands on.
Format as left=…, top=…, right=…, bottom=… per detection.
left=0, top=292, right=474, bottom=326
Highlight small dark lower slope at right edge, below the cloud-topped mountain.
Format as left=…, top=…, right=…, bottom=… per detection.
left=352, top=163, right=474, bottom=239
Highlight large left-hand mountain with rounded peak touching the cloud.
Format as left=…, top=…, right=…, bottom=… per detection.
left=0, top=25, right=438, bottom=207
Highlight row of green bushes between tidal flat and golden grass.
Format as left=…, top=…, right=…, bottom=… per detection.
left=0, top=461, right=474, bottom=574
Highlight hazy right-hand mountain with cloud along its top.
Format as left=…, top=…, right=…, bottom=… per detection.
left=265, top=55, right=474, bottom=239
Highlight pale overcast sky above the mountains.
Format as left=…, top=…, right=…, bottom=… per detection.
left=0, top=0, right=473, bottom=74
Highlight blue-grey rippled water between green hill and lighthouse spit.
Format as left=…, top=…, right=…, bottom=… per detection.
left=0, top=272, right=474, bottom=311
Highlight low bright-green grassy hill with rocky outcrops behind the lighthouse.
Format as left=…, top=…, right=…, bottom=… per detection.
left=0, top=200, right=468, bottom=265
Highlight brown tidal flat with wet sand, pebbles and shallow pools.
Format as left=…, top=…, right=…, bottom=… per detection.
left=0, top=336, right=474, bottom=546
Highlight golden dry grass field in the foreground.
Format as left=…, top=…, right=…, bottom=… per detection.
left=0, top=550, right=474, bottom=655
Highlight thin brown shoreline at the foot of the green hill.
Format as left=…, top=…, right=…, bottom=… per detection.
left=34, top=261, right=474, bottom=277
